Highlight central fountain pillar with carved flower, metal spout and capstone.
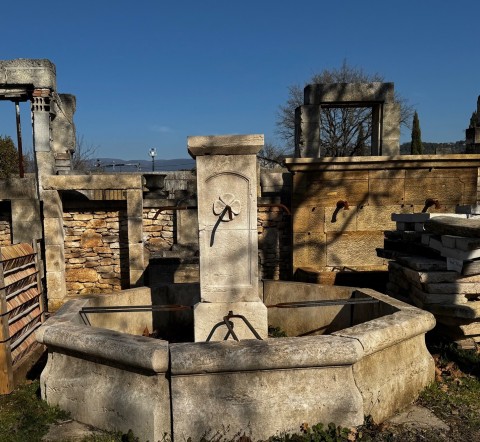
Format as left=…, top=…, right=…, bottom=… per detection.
left=188, top=135, right=268, bottom=341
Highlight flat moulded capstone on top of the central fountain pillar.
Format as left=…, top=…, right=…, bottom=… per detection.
left=187, top=134, right=264, bottom=158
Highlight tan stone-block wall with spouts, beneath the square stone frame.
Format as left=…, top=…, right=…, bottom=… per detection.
left=286, top=155, right=480, bottom=272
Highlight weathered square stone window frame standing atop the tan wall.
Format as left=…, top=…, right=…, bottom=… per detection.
left=295, top=82, right=400, bottom=158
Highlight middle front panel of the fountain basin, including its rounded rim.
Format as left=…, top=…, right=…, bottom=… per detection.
left=171, top=336, right=363, bottom=440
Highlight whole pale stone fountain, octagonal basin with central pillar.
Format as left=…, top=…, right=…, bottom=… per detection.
left=37, top=135, right=435, bottom=441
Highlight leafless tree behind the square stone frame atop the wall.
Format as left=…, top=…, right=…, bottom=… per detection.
left=276, top=61, right=413, bottom=156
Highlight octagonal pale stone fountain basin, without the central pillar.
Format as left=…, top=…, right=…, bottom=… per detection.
left=37, top=281, right=435, bottom=441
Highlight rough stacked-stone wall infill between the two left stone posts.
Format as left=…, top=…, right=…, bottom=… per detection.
left=63, top=209, right=128, bottom=295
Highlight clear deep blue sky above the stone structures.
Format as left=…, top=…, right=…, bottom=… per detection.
left=0, top=0, right=480, bottom=160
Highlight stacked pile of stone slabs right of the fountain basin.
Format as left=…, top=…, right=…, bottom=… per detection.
left=377, top=206, right=480, bottom=348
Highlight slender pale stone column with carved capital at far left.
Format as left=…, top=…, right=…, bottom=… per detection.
left=31, top=89, right=55, bottom=190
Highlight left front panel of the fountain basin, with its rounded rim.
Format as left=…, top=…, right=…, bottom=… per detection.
left=37, top=322, right=170, bottom=440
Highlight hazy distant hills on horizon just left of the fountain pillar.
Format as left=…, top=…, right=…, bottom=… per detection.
left=90, top=158, right=195, bottom=172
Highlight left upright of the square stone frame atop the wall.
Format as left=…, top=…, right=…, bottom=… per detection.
left=295, top=105, right=322, bottom=158
